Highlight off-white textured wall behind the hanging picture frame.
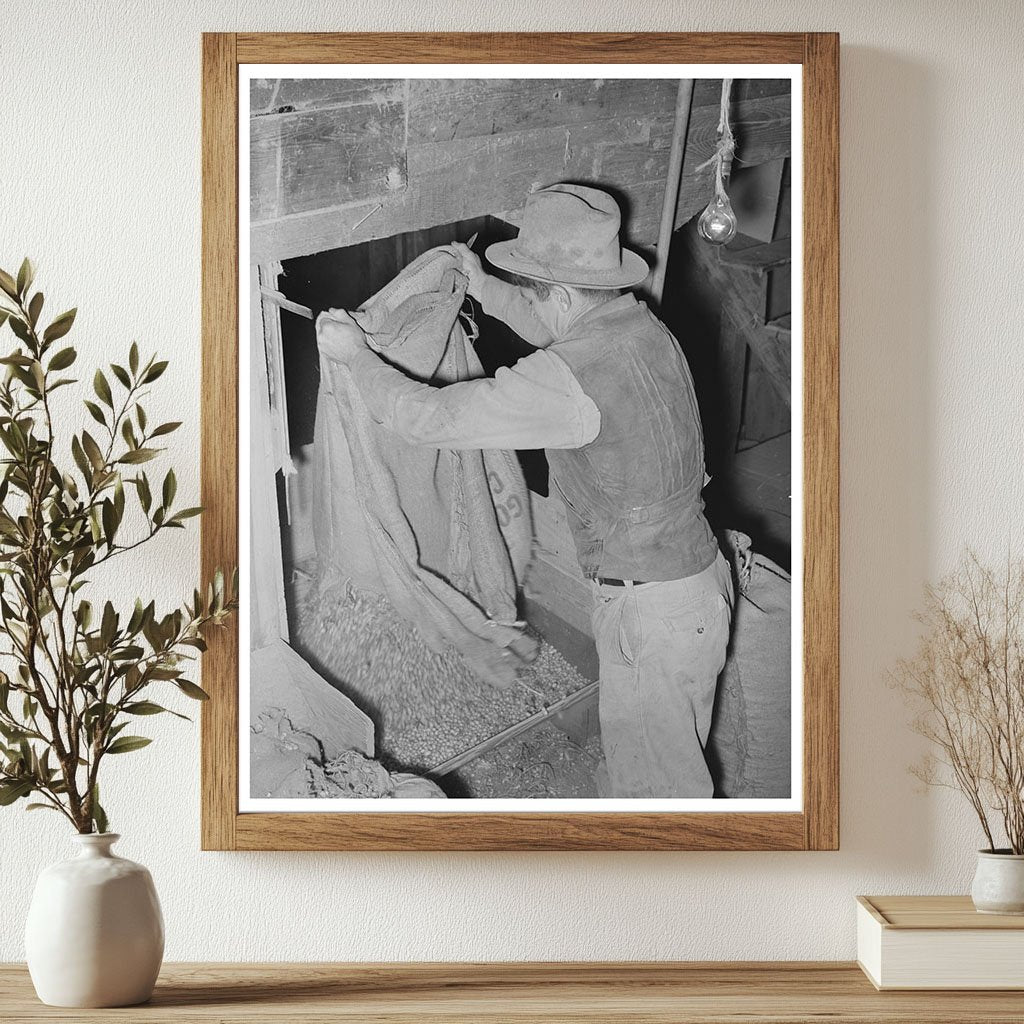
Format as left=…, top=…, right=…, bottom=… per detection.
left=0, top=0, right=1024, bottom=959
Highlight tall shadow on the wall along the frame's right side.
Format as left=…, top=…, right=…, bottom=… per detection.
left=840, top=46, right=941, bottom=871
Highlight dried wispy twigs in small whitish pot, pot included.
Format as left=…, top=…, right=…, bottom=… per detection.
left=895, top=553, right=1024, bottom=913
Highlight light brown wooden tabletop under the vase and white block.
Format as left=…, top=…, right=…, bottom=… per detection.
left=0, top=963, right=1024, bottom=1024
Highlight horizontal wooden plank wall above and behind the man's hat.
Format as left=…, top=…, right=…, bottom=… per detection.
left=250, top=79, right=790, bottom=262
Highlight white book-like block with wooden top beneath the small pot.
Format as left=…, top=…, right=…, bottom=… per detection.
left=857, top=896, right=1024, bottom=987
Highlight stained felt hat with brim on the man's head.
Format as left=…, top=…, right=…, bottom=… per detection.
left=486, top=184, right=649, bottom=288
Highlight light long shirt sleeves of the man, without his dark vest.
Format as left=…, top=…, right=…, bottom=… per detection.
left=349, top=278, right=601, bottom=450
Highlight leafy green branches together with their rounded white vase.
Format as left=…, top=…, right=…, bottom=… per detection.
left=0, top=260, right=238, bottom=1006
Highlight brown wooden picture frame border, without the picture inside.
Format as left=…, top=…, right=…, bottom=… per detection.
left=202, top=33, right=840, bottom=850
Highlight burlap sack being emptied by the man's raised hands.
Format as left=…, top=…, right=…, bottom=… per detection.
left=314, top=249, right=535, bottom=685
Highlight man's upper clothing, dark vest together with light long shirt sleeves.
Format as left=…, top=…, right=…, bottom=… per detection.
left=350, top=278, right=718, bottom=582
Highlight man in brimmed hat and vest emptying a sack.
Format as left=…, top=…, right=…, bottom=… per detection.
left=317, top=184, right=733, bottom=799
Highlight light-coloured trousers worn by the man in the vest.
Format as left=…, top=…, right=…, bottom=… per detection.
left=592, top=552, right=733, bottom=799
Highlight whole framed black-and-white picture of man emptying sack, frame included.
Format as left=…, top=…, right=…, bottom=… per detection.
left=202, top=33, right=839, bottom=850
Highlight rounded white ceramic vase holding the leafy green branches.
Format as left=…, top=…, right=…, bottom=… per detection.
left=25, top=833, right=164, bottom=1007
